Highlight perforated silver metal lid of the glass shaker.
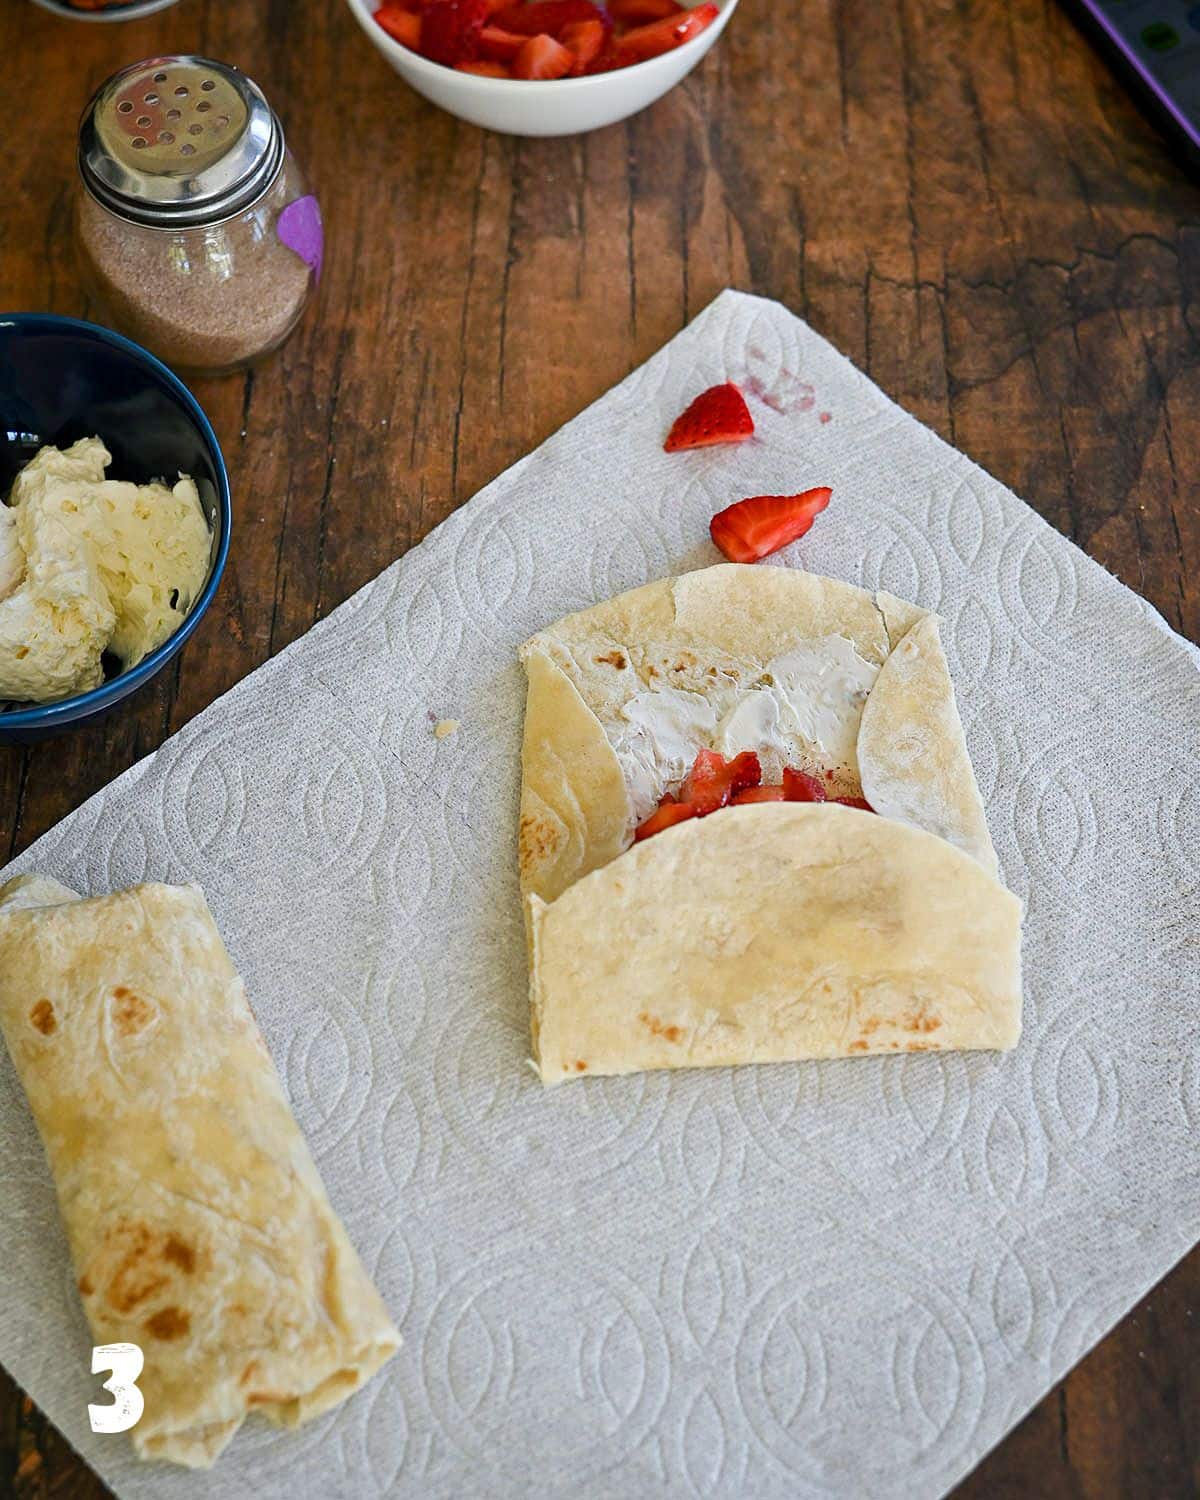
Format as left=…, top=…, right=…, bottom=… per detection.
left=78, top=56, right=284, bottom=228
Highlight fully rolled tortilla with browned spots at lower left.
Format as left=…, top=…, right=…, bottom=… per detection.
left=0, top=876, right=399, bottom=1467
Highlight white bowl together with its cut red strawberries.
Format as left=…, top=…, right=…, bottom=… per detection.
left=348, top=0, right=738, bottom=135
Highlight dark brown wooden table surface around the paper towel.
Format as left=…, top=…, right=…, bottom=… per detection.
left=0, top=0, right=1200, bottom=1500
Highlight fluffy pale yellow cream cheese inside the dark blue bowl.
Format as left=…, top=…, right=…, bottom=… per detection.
left=0, top=438, right=210, bottom=704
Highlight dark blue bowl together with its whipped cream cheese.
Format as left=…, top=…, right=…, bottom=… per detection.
left=0, top=314, right=230, bottom=744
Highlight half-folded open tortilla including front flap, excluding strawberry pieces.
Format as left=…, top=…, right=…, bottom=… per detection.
left=519, top=564, right=1020, bottom=1083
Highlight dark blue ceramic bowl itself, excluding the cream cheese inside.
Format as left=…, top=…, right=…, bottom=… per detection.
left=0, top=312, right=230, bottom=744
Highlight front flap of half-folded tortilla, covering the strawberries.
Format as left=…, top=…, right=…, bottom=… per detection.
left=531, top=803, right=1022, bottom=1085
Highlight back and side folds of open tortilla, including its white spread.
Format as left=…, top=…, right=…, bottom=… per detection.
left=519, top=563, right=996, bottom=902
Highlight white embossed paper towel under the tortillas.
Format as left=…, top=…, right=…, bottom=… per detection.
left=0, top=293, right=1200, bottom=1500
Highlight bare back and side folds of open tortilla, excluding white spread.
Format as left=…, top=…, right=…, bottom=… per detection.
left=519, top=563, right=996, bottom=902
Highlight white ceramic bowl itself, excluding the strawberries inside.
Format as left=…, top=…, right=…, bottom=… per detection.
left=347, top=0, right=738, bottom=135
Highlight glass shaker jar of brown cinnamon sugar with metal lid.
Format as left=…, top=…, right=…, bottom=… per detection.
left=77, top=57, right=321, bottom=375
